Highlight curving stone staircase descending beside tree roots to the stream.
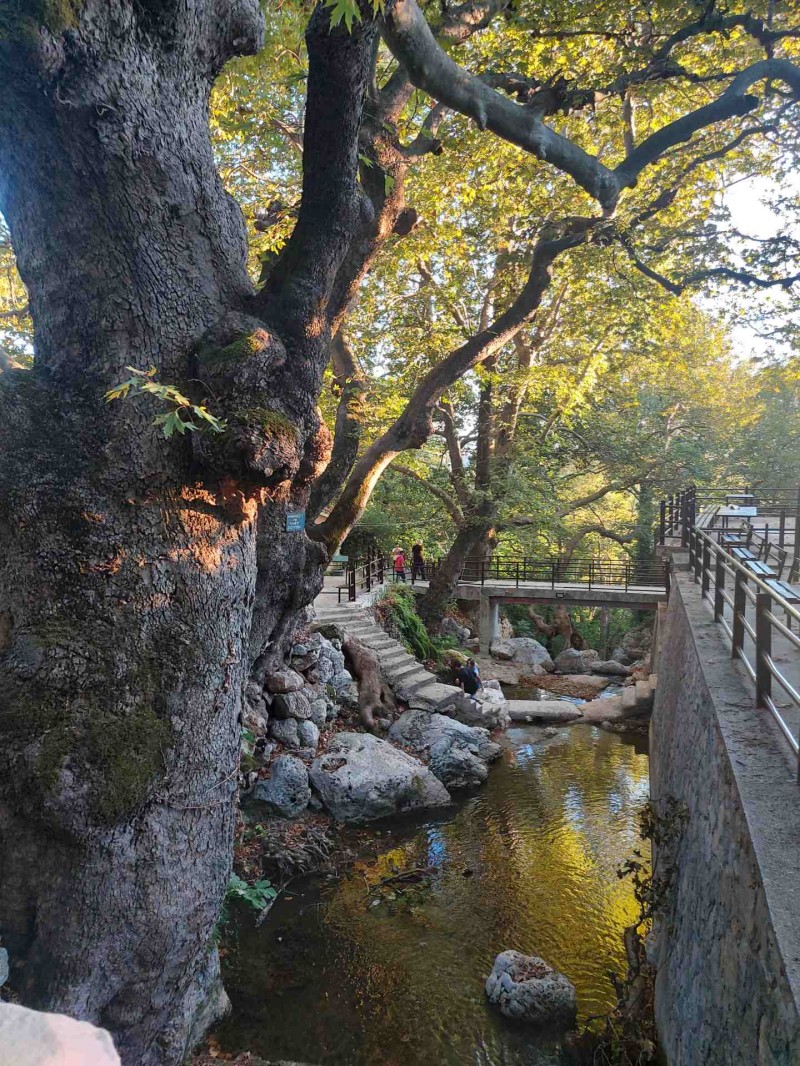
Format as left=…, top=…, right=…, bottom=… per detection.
left=314, top=597, right=461, bottom=711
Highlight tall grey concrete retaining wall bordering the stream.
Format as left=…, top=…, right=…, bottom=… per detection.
left=651, top=575, right=800, bottom=1066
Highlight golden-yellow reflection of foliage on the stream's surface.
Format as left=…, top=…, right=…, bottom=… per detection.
left=309, top=729, right=647, bottom=1062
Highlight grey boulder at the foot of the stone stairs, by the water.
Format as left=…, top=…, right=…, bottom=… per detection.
left=389, top=711, right=502, bottom=789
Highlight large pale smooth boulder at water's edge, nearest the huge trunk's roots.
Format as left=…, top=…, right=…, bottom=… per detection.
left=309, top=732, right=450, bottom=823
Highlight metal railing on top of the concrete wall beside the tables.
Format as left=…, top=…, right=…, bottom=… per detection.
left=688, top=527, right=800, bottom=779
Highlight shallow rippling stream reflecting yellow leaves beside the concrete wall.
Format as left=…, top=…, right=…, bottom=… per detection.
left=215, top=725, right=649, bottom=1066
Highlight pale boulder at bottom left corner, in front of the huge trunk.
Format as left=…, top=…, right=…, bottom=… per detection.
left=0, top=1003, right=119, bottom=1066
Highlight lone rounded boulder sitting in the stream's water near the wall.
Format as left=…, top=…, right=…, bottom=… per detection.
left=486, top=951, right=577, bottom=1028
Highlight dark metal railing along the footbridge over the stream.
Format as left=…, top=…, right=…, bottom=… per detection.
left=431, top=555, right=670, bottom=592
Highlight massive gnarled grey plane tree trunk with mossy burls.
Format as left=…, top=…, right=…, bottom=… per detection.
left=0, top=0, right=370, bottom=1066
